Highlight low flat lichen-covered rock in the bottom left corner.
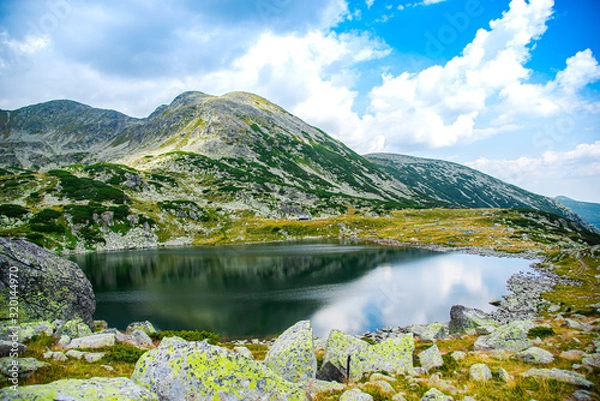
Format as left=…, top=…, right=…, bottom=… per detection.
left=0, top=377, right=158, bottom=401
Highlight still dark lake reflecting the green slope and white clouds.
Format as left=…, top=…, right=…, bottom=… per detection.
left=73, top=243, right=530, bottom=337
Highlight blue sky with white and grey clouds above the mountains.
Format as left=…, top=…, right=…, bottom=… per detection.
left=0, top=0, right=600, bottom=202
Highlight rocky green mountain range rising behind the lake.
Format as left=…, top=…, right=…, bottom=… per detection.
left=0, top=92, right=591, bottom=250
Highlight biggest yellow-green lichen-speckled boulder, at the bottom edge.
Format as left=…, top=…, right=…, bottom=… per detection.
left=132, top=338, right=306, bottom=401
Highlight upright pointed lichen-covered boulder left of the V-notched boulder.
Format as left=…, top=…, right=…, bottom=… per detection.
left=264, top=320, right=317, bottom=383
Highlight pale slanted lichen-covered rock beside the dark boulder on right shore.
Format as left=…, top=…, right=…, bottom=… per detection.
left=474, top=321, right=535, bottom=351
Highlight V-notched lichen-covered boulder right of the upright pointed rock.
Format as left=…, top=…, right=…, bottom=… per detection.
left=323, top=330, right=415, bottom=382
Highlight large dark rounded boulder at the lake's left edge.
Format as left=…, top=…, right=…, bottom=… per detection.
left=0, top=237, right=96, bottom=327
